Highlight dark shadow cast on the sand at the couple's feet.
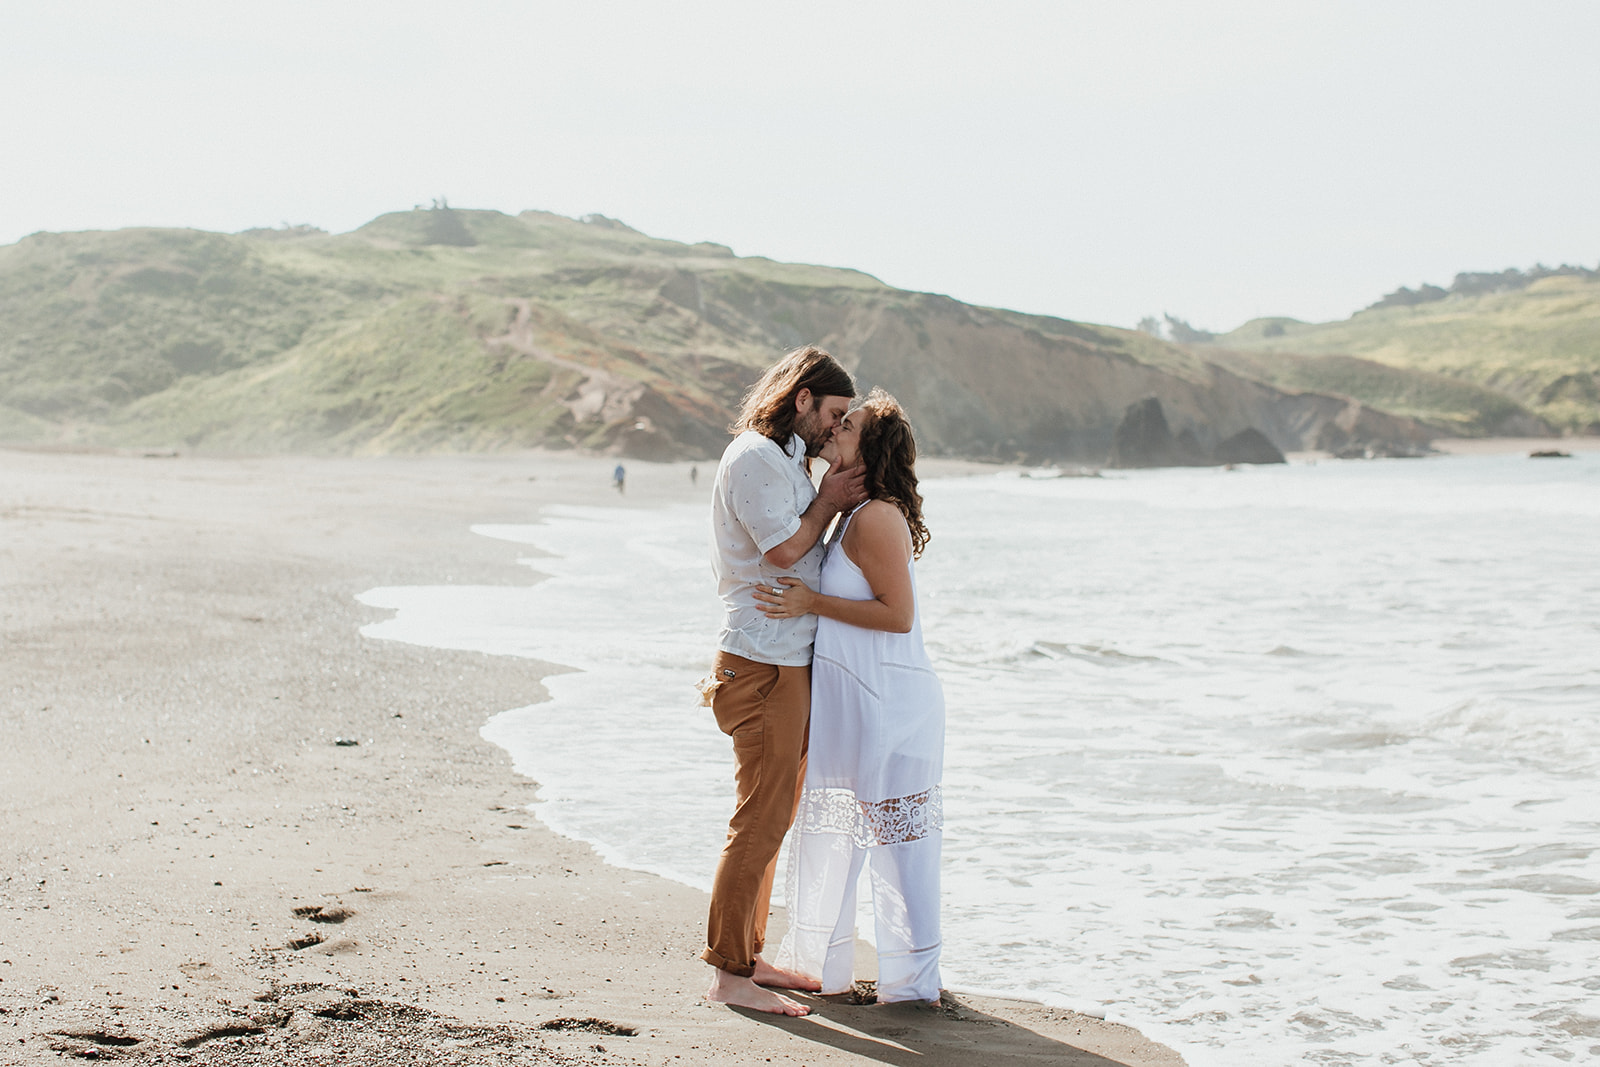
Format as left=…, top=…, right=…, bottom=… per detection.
left=733, top=990, right=1145, bottom=1067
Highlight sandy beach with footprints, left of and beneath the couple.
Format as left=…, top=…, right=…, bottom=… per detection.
left=0, top=450, right=1181, bottom=1067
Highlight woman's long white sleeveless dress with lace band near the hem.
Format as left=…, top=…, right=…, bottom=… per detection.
left=778, top=508, right=944, bottom=1001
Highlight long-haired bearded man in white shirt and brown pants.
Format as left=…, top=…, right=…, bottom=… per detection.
left=701, top=347, right=866, bottom=1016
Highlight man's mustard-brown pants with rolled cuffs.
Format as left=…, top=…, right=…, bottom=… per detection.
left=701, top=651, right=811, bottom=977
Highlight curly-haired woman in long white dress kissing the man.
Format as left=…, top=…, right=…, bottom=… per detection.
left=757, top=389, right=944, bottom=1001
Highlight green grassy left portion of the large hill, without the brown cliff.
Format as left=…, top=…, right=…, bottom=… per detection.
left=0, top=210, right=851, bottom=451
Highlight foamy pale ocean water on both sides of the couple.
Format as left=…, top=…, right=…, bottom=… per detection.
left=360, top=453, right=1600, bottom=1067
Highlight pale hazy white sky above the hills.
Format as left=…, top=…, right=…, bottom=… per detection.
left=0, top=0, right=1600, bottom=331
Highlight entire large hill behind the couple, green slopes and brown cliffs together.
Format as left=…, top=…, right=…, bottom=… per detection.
left=0, top=208, right=1440, bottom=462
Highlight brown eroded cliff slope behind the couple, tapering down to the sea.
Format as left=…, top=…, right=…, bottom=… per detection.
left=553, top=269, right=1430, bottom=464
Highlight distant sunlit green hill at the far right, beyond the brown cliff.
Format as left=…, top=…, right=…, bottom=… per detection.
left=1197, top=279, right=1600, bottom=435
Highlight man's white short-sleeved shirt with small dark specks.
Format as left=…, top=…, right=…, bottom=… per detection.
left=710, top=430, right=822, bottom=667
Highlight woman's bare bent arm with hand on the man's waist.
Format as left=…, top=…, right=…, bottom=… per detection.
left=755, top=501, right=917, bottom=633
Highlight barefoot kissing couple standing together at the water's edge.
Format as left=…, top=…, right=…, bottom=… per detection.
left=701, top=346, right=944, bottom=1016
